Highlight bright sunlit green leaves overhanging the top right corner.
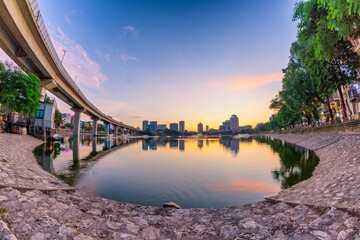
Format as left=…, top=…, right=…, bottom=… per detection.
left=293, top=0, right=360, bottom=61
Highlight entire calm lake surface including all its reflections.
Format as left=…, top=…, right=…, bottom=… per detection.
left=34, top=136, right=319, bottom=208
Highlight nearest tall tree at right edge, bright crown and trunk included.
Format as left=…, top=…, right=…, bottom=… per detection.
left=294, top=0, right=360, bottom=117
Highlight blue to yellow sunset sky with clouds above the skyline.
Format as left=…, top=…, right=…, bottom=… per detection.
left=0, top=0, right=296, bottom=130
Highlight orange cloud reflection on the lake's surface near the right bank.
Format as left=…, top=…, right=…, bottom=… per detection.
left=210, top=179, right=280, bottom=193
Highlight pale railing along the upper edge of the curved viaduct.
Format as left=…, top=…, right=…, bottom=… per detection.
left=29, top=0, right=134, bottom=127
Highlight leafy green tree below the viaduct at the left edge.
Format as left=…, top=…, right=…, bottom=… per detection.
left=0, top=62, right=41, bottom=115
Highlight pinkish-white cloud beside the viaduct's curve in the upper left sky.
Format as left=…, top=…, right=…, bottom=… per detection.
left=49, top=25, right=108, bottom=90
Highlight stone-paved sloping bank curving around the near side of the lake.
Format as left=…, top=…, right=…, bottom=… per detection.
left=0, top=134, right=360, bottom=240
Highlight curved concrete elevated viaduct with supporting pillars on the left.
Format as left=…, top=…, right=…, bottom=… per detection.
left=0, top=0, right=137, bottom=141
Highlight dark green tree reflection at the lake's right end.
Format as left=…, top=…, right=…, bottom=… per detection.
left=256, top=137, right=319, bottom=188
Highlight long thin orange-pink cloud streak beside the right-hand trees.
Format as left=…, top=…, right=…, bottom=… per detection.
left=206, top=73, right=284, bottom=90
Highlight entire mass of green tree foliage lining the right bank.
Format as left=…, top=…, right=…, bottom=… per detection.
left=267, top=0, right=360, bottom=129
